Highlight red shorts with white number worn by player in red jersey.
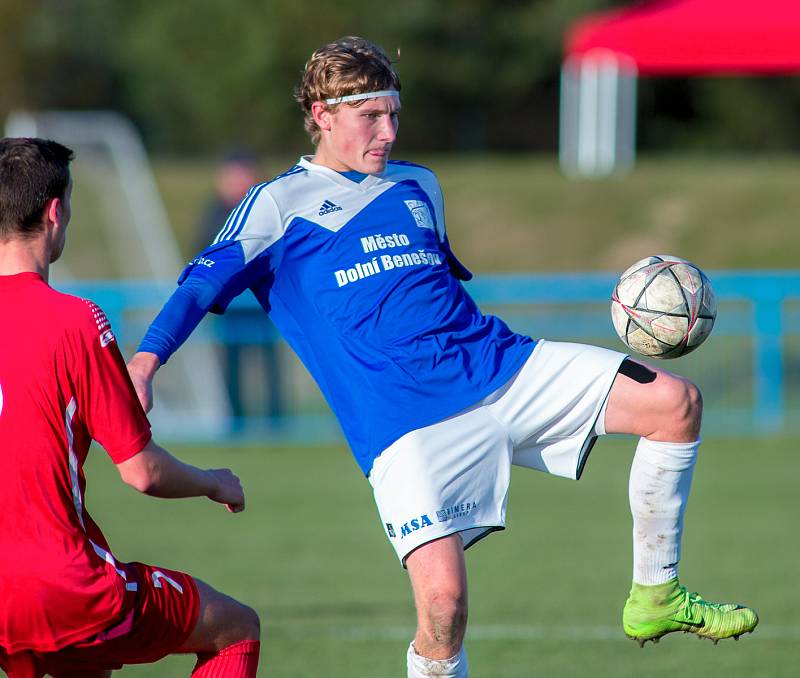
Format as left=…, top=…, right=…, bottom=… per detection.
left=0, top=563, right=200, bottom=678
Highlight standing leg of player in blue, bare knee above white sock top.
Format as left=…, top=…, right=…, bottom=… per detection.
left=406, top=534, right=467, bottom=678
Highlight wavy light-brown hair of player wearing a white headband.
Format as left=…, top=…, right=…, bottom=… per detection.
left=294, top=36, right=400, bottom=146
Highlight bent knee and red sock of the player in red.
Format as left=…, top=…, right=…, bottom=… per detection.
left=178, top=579, right=261, bottom=678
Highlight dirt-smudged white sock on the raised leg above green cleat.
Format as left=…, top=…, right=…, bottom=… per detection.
left=628, top=438, right=700, bottom=585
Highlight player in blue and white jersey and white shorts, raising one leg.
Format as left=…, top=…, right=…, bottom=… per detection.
left=129, top=38, right=758, bottom=678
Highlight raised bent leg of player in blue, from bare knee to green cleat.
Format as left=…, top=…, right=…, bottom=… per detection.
left=605, top=360, right=758, bottom=645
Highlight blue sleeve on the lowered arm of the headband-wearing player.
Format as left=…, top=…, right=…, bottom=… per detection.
left=138, top=241, right=268, bottom=365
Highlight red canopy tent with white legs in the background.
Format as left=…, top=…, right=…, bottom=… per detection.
left=562, top=0, right=800, bottom=174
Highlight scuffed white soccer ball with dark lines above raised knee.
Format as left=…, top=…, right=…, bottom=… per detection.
left=611, top=255, right=717, bottom=358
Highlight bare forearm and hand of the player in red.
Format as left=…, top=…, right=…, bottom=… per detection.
left=117, top=440, right=244, bottom=513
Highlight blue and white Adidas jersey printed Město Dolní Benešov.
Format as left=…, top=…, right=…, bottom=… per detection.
left=140, top=158, right=534, bottom=474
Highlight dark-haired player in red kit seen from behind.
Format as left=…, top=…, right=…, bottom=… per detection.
left=0, top=139, right=259, bottom=678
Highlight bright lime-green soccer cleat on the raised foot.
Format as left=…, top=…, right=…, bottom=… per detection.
left=622, top=578, right=758, bottom=647
